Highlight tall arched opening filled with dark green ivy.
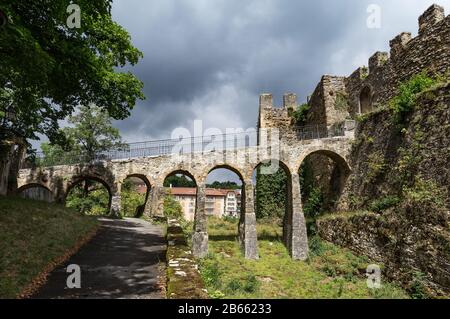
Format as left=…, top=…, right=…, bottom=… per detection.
left=253, top=160, right=292, bottom=252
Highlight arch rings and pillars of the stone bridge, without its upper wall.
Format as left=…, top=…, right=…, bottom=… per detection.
left=19, top=150, right=350, bottom=259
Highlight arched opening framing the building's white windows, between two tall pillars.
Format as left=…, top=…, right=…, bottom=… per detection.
left=205, top=165, right=245, bottom=244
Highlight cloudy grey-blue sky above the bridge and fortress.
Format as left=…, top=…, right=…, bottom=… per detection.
left=113, top=0, right=449, bottom=141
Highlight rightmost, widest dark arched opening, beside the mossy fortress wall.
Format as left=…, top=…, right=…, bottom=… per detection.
left=299, top=150, right=350, bottom=236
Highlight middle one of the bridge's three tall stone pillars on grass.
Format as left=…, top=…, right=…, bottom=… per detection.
left=239, top=180, right=259, bottom=259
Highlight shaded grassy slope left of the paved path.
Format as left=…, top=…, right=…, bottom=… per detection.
left=0, top=197, right=98, bottom=298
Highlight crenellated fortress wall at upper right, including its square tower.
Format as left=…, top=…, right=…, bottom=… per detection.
left=307, top=5, right=450, bottom=126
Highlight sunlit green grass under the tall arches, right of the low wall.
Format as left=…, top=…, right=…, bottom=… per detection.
left=200, top=219, right=408, bottom=299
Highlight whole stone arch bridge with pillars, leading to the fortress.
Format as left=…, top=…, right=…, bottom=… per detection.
left=17, top=128, right=354, bottom=260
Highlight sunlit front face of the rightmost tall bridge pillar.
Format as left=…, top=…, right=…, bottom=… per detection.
left=286, top=173, right=308, bottom=260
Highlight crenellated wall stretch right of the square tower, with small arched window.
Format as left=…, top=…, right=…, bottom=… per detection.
left=345, top=5, right=450, bottom=114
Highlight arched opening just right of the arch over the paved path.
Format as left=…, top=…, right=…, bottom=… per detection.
left=120, top=174, right=151, bottom=218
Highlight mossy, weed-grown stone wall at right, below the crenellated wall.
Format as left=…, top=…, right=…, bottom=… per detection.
left=318, top=83, right=450, bottom=296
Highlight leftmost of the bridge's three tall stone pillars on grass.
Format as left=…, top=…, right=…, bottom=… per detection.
left=192, top=185, right=208, bottom=258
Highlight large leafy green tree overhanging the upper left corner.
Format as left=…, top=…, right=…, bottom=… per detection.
left=0, top=0, right=144, bottom=186
